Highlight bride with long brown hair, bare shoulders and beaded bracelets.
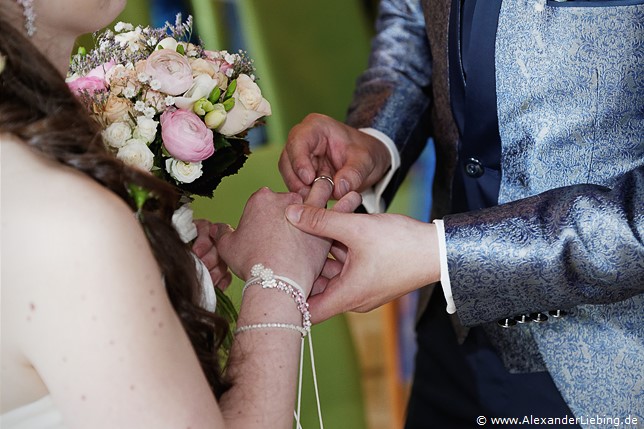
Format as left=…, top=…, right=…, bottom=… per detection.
left=0, top=0, right=359, bottom=429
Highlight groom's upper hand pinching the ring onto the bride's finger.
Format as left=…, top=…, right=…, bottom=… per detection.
left=279, top=114, right=391, bottom=200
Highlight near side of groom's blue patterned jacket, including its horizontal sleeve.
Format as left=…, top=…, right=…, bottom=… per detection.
left=445, top=0, right=644, bottom=419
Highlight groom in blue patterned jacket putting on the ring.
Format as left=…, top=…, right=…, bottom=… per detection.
left=280, top=0, right=644, bottom=428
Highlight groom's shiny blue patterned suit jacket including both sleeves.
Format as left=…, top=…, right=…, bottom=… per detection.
left=347, top=0, right=644, bottom=422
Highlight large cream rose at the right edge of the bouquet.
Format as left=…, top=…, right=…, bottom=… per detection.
left=217, top=74, right=271, bottom=136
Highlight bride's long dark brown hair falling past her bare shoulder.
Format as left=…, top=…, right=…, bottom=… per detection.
left=0, top=11, right=229, bottom=397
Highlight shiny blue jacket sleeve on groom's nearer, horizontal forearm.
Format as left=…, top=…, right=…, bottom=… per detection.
left=444, top=166, right=644, bottom=326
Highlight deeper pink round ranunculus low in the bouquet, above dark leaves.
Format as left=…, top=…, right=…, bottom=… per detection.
left=160, top=109, right=215, bottom=162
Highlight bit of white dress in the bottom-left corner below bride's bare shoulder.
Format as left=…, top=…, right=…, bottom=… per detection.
left=0, top=395, right=65, bottom=429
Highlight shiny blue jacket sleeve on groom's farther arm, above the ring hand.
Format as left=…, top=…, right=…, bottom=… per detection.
left=347, top=0, right=431, bottom=203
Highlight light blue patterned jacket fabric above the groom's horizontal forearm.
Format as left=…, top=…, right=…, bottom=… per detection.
left=496, top=0, right=644, bottom=203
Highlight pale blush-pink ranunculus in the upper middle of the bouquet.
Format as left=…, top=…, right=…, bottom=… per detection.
left=145, top=49, right=192, bottom=95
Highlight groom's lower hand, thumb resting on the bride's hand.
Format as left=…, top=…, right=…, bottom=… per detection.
left=286, top=205, right=440, bottom=323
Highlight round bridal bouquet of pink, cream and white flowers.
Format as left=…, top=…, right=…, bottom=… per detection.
left=67, top=15, right=271, bottom=201
